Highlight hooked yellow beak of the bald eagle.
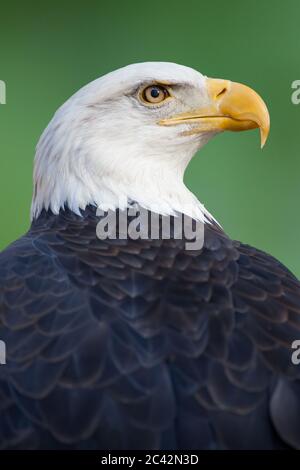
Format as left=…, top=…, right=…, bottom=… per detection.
left=160, top=78, right=270, bottom=147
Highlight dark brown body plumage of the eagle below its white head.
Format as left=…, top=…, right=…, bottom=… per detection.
left=0, top=207, right=300, bottom=449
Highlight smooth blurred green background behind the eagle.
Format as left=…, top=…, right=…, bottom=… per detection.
left=0, top=0, right=300, bottom=276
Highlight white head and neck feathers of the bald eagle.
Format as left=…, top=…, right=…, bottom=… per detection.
left=31, top=62, right=218, bottom=221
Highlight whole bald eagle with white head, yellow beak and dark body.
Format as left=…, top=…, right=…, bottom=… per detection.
left=0, top=62, right=300, bottom=449
